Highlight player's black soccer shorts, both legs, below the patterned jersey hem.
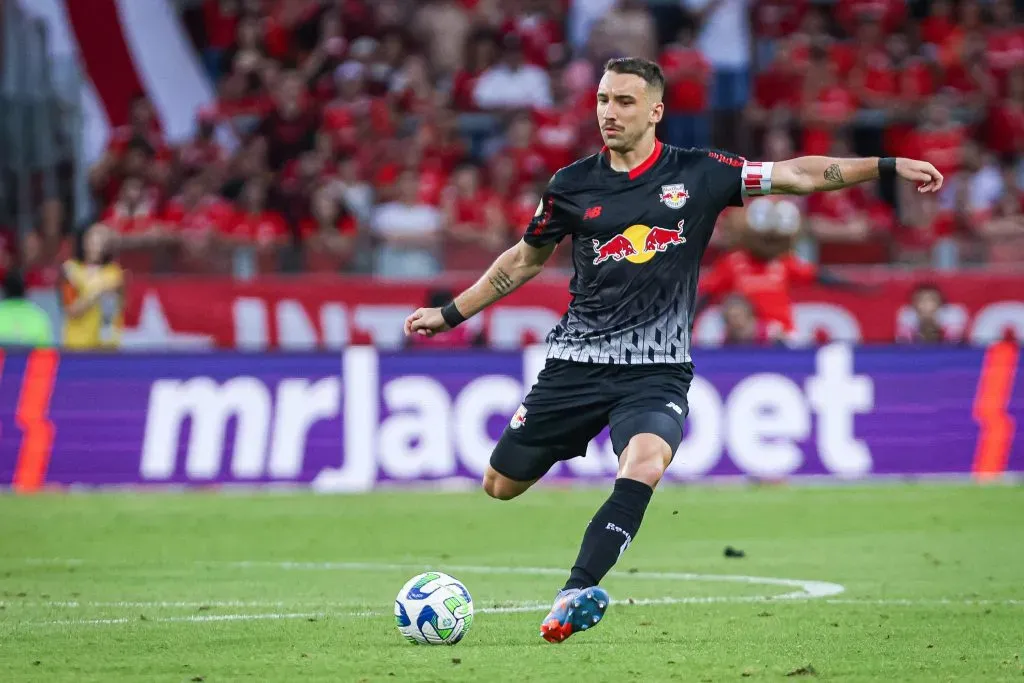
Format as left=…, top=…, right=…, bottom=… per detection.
left=490, top=358, right=693, bottom=481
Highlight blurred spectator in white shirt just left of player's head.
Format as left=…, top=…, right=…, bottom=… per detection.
left=473, top=35, right=552, bottom=111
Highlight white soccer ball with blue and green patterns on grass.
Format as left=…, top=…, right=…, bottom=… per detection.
left=394, top=571, right=473, bottom=645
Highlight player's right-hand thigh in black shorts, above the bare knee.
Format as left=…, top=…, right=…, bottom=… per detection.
left=609, top=364, right=693, bottom=459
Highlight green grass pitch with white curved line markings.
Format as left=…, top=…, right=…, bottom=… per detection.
left=0, top=484, right=1024, bottom=683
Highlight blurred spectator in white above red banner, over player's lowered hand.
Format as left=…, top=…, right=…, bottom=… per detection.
left=372, top=171, right=442, bottom=278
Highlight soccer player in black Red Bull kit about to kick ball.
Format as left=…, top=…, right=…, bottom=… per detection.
left=404, top=58, right=942, bottom=642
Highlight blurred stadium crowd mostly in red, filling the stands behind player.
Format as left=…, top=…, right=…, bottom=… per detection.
left=6, top=0, right=1024, bottom=290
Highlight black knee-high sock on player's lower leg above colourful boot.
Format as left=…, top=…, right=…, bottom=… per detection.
left=562, top=479, right=654, bottom=590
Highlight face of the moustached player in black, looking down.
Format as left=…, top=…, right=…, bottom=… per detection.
left=597, top=72, right=665, bottom=153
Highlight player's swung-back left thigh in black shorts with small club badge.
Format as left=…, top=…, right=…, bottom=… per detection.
left=490, top=360, right=609, bottom=482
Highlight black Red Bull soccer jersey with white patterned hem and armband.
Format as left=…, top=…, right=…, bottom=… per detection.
left=523, top=141, right=767, bottom=365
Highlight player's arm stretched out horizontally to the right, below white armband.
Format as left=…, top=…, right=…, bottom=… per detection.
left=771, top=157, right=942, bottom=195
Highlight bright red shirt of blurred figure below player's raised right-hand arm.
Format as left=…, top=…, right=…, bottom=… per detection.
left=700, top=251, right=818, bottom=332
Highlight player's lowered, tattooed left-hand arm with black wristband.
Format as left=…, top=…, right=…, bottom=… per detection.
left=406, top=241, right=555, bottom=337
